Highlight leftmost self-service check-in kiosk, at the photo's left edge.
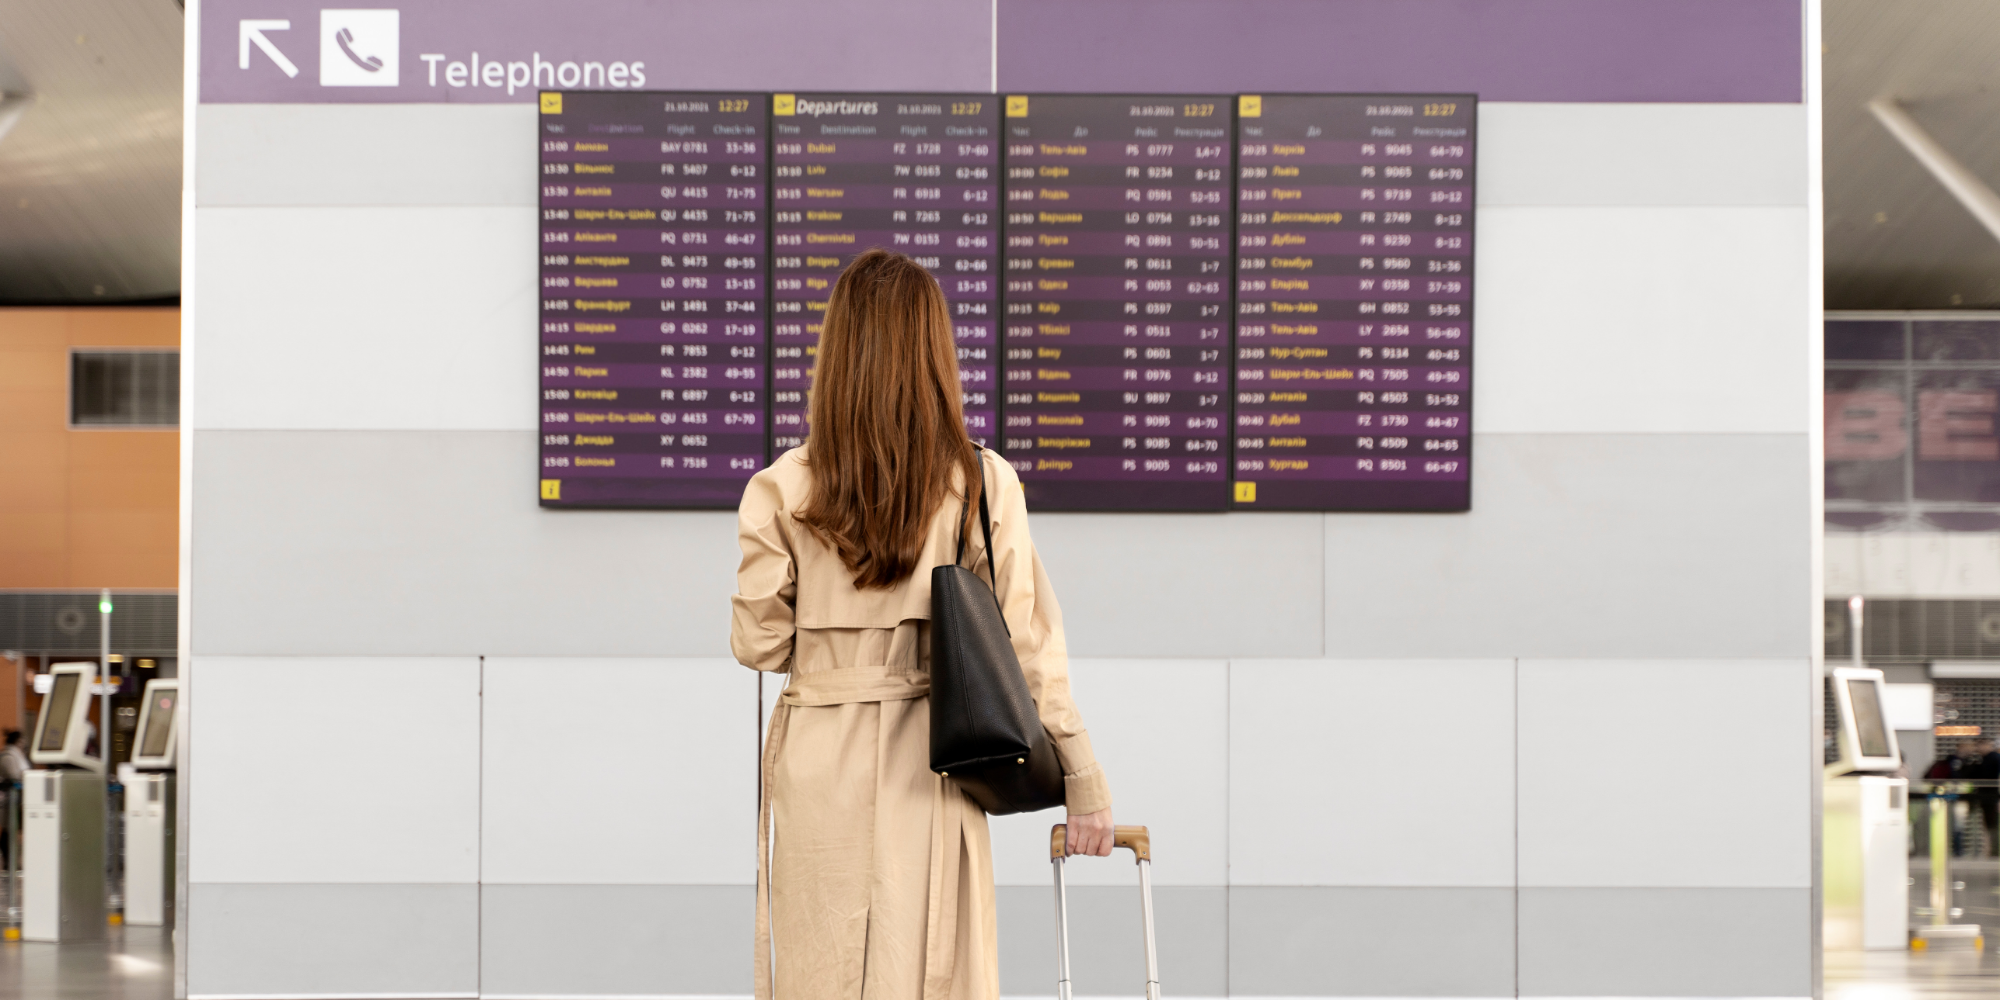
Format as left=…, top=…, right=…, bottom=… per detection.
left=20, top=664, right=106, bottom=942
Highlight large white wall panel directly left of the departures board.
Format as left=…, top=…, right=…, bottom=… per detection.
left=192, top=206, right=536, bottom=430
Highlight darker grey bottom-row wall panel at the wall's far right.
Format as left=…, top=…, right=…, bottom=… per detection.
left=1520, top=888, right=1818, bottom=996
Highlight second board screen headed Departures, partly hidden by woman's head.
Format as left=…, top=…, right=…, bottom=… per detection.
left=772, top=94, right=1000, bottom=456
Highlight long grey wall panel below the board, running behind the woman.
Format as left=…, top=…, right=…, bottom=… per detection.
left=194, top=430, right=1322, bottom=656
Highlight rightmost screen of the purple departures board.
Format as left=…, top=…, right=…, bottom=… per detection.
left=1232, top=94, right=1478, bottom=510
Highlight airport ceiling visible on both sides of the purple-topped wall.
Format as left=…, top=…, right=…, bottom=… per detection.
left=0, top=0, right=2000, bottom=308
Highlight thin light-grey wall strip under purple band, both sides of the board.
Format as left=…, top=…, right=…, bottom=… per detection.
left=196, top=102, right=1806, bottom=208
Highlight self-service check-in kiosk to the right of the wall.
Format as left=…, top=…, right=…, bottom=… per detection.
left=1822, top=666, right=1910, bottom=950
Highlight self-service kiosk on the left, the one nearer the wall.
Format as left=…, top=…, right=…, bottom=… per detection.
left=124, top=678, right=180, bottom=926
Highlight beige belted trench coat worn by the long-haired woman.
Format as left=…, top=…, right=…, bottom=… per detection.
left=730, top=448, right=1110, bottom=1000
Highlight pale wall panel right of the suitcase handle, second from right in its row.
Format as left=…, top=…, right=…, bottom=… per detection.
left=1230, top=660, right=1514, bottom=888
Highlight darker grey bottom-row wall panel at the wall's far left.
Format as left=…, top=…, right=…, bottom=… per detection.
left=188, top=888, right=480, bottom=998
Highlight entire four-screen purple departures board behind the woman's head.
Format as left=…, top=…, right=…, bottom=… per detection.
left=538, top=92, right=1476, bottom=510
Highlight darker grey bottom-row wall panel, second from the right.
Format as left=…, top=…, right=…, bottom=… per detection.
left=1230, top=886, right=1514, bottom=996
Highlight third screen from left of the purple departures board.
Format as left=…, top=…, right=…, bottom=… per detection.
left=1002, top=94, right=1236, bottom=510
